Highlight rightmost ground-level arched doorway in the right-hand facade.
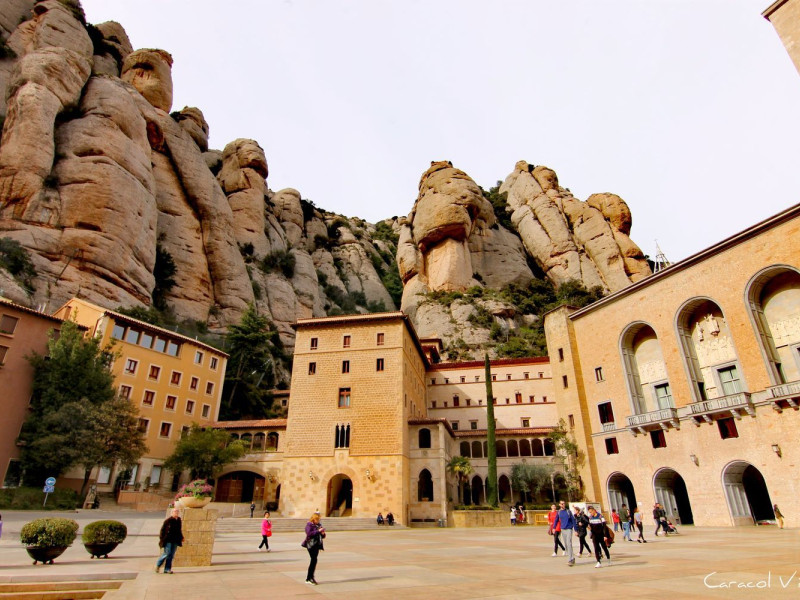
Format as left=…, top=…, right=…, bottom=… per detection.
left=722, top=460, right=775, bottom=527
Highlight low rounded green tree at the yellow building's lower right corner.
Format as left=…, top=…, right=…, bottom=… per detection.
left=164, top=424, right=246, bottom=479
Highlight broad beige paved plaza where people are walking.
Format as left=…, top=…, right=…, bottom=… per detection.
left=0, top=513, right=800, bottom=600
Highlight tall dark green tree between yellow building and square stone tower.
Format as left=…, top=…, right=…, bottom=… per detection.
left=220, top=304, right=281, bottom=420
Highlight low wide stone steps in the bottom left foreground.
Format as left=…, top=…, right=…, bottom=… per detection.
left=0, top=573, right=136, bottom=600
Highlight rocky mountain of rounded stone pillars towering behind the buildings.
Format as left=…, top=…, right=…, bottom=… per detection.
left=0, top=0, right=650, bottom=360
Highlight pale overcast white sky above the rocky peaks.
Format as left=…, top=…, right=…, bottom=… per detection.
left=82, top=0, right=800, bottom=262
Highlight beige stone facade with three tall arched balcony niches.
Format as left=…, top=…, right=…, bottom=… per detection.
left=545, top=206, right=800, bottom=526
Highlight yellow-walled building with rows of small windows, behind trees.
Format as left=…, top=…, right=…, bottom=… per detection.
left=55, top=298, right=228, bottom=491
